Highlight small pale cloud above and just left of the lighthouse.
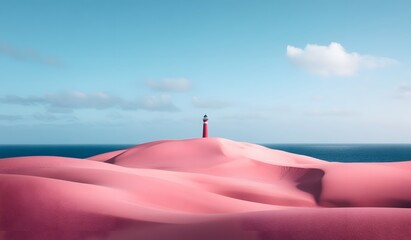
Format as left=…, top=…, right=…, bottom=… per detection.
left=146, top=78, right=191, bottom=92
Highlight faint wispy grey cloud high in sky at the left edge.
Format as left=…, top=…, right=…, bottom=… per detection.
left=0, top=42, right=63, bottom=67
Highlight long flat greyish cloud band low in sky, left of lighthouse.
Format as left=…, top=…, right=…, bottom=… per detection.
left=0, top=91, right=178, bottom=113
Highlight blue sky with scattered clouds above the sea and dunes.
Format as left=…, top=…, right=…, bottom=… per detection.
left=0, top=0, right=411, bottom=144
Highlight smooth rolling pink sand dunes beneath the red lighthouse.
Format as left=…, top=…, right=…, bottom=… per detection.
left=0, top=138, right=411, bottom=240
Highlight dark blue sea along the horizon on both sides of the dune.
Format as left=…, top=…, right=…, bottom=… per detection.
left=0, top=144, right=411, bottom=162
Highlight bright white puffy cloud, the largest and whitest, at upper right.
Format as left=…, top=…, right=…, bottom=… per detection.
left=287, top=42, right=397, bottom=76
